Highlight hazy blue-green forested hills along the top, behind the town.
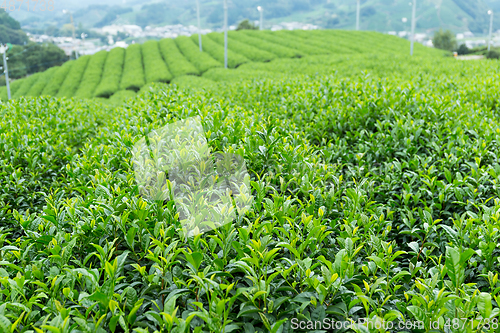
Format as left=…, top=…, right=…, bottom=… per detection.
left=6, top=0, right=500, bottom=34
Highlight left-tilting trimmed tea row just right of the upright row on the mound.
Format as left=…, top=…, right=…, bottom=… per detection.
left=142, top=41, right=173, bottom=83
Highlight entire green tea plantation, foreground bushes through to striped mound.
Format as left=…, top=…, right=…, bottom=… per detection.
left=0, top=31, right=500, bottom=333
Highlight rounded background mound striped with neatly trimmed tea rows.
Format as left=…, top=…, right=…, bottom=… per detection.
left=0, top=30, right=441, bottom=100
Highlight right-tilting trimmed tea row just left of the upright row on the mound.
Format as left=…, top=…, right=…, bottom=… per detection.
left=94, top=47, right=125, bottom=98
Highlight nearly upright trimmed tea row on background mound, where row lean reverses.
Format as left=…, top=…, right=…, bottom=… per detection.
left=120, top=44, right=146, bottom=91
